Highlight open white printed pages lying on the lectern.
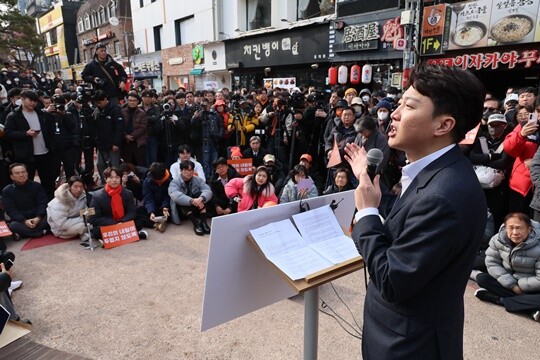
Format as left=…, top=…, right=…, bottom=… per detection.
left=250, top=206, right=358, bottom=280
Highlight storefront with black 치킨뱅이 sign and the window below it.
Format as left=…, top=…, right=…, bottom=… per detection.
left=225, top=22, right=329, bottom=90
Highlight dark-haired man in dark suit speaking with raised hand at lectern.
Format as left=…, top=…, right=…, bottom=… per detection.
left=346, top=65, right=487, bottom=360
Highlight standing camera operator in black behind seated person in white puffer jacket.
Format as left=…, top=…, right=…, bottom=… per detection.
left=44, top=95, right=80, bottom=179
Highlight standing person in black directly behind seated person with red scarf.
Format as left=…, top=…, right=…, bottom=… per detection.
left=92, top=90, right=125, bottom=182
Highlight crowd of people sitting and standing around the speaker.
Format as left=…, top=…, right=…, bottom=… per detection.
left=0, top=46, right=540, bottom=324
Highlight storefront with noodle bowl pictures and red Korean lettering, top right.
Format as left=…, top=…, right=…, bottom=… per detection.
left=420, top=0, right=540, bottom=100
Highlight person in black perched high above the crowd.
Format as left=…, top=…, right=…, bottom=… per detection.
left=81, top=43, right=127, bottom=104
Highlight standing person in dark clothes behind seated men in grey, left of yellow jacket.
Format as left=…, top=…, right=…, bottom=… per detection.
left=190, top=98, right=224, bottom=179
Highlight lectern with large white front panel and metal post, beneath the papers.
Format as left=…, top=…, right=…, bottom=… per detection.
left=201, top=190, right=363, bottom=359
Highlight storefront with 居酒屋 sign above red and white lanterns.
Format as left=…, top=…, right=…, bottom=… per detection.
left=329, top=8, right=405, bottom=90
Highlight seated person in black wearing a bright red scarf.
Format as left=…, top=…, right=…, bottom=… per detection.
left=90, top=167, right=148, bottom=240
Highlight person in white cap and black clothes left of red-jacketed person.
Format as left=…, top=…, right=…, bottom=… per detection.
left=469, top=114, right=514, bottom=229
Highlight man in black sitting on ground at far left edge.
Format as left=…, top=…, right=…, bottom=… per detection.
left=2, top=163, right=49, bottom=240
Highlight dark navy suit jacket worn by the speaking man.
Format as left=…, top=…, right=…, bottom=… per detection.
left=352, top=146, right=487, bottom=360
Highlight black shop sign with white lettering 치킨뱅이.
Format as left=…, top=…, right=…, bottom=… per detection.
left=225, top=24, right=328, bottom=68
